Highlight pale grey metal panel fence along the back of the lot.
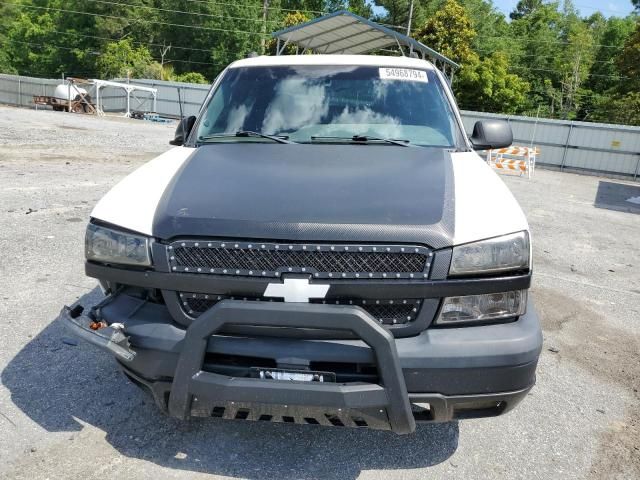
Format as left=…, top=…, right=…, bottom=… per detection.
left=0, top=74, right=640, bottom=180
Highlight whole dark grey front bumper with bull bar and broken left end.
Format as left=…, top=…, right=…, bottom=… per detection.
left=62, top=295, right=542, bottom=433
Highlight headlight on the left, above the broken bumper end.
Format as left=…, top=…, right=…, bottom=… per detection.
left=85, top=224, right=151, bottom=266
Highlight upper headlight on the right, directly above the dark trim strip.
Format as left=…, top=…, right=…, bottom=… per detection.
left=449, top=232, right=529, bottom=275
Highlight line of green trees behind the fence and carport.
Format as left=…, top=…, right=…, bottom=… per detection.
left=0, top=0, right=640, bottom=124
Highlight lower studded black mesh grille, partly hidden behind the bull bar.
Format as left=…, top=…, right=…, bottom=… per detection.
left=179, top=293, right=422, bottom=325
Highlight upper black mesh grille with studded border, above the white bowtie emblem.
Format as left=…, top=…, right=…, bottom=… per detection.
left=168, top=241, right=433, bottom=279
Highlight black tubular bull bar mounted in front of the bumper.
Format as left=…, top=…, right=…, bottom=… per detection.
left=168, top=300, right=416, bottom=434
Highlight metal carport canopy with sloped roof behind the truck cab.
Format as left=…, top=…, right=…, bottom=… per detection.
left=272, top=10, right=459, bottom=69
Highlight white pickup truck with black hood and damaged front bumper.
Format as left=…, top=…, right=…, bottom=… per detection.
left=63, top=55, right=542, bottom=433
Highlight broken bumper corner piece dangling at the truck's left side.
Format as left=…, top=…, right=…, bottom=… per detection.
left=60, top=305, right=136, bottom=362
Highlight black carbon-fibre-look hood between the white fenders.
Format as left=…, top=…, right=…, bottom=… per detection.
left=153, top=143, right=454, bottom=248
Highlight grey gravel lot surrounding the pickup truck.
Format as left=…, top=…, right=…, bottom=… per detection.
left=0, top=107, right=640, bottom=480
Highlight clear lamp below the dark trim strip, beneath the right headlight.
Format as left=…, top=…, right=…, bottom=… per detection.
left=436, top=290, right=527, bottom=325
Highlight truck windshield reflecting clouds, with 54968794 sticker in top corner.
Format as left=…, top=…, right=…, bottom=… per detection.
left=196, top=66, right=458, bottom=147
